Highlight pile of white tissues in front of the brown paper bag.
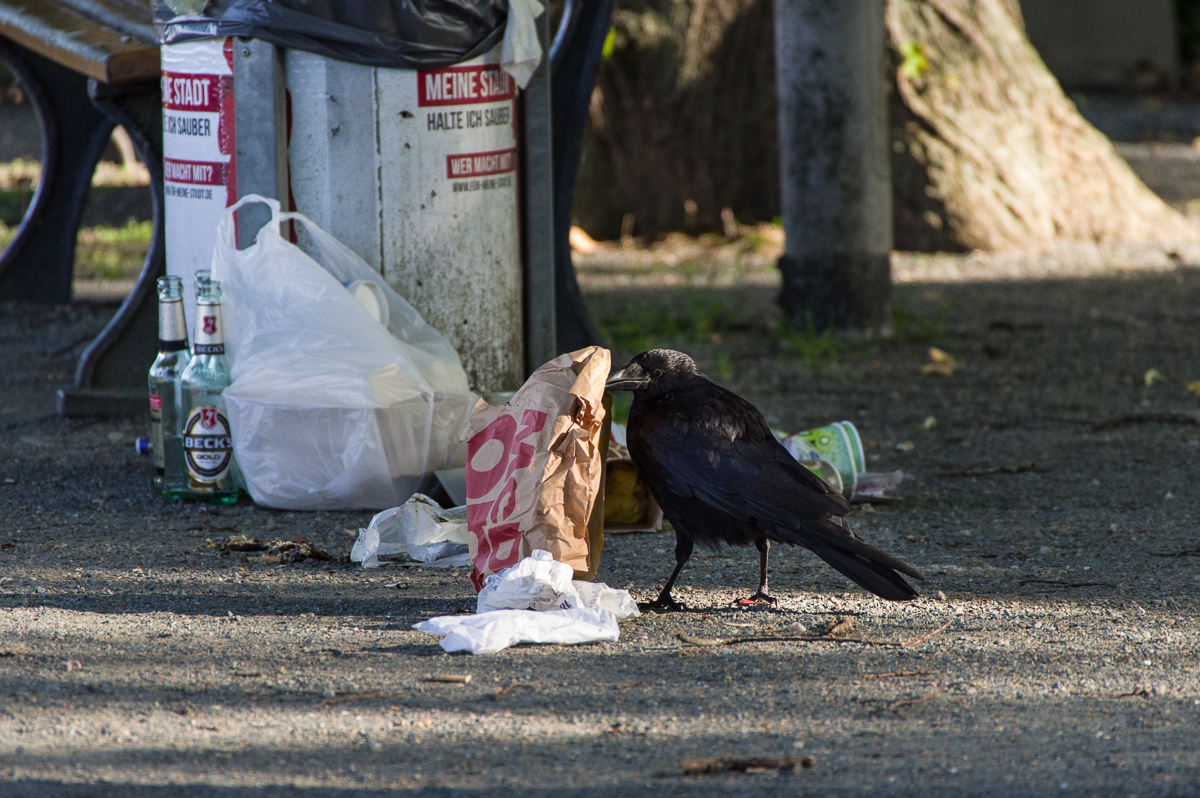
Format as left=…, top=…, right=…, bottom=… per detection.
left=413, top=551, right=641, bottom=654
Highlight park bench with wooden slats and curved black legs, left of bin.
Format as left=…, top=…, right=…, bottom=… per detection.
left=0, top=0, right=164, bottom=415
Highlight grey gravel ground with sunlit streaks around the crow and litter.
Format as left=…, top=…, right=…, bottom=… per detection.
left=0, top=245, right=1200, bottom=798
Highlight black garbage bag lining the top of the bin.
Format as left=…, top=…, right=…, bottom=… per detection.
left=154, top=0, right=509, bottom=70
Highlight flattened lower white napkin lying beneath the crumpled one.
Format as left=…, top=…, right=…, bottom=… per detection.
left=413, top=607, right=620, bottom=654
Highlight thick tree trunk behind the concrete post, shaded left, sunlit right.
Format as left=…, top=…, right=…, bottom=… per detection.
left=575, top=0, right=1196, bottom=251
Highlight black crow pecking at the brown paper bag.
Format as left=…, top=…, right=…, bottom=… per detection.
left=607, top=349, right=925, bottom=610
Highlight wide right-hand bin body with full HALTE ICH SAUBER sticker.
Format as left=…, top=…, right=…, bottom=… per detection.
left=284, top=47, right=524, bottom=391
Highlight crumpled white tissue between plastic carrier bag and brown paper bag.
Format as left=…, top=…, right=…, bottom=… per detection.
left=350, top=493, right=470, bottom=568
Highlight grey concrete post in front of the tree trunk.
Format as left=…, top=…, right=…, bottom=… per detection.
left=775, top=0, right=892, bottom=336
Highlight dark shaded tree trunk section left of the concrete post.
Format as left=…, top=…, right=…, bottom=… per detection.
left=575, top=0, right=780, bottom=239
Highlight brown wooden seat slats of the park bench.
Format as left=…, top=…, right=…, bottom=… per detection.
left=0, top=0, right=161, bottom=83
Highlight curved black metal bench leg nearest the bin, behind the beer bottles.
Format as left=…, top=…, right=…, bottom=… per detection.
left=59, top=80, right=166, bottom=416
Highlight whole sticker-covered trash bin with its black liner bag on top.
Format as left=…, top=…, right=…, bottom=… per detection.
left=155, top=0, right=540, bottom=392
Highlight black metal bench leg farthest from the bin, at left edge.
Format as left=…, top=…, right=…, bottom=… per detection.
left=0, top=38, right=113, bottom=305
